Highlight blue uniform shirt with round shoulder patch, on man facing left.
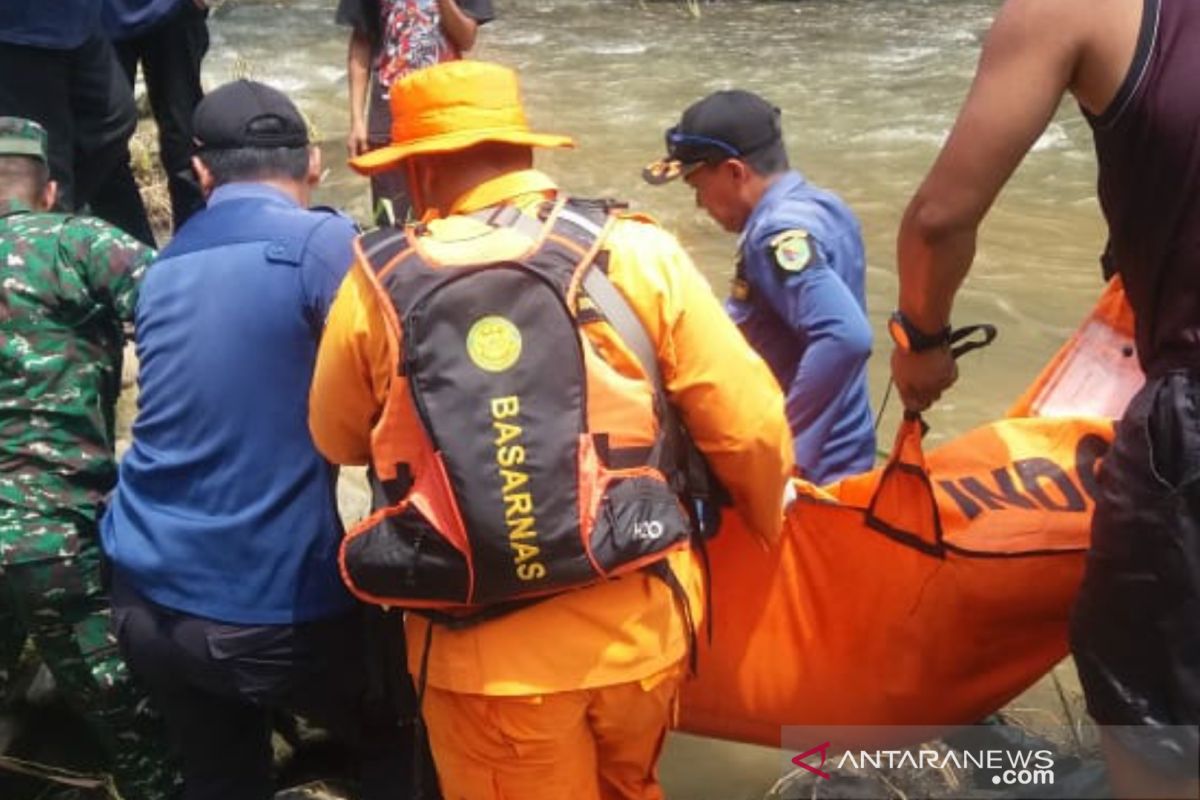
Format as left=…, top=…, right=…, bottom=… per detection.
left=726, top=172, right=875, bottom=483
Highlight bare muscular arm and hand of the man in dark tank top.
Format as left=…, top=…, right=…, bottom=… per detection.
left=893, top=0, right=1086, bottom=409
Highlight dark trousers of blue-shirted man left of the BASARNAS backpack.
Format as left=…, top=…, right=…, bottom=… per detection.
left=112, top=573, right=422, bottom=800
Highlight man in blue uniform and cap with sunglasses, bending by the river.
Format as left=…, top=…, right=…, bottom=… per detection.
left=642, top=90, right=875, bottom=483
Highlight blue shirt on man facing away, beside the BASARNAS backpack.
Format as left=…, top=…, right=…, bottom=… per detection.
left=102, top=184, right=356, bottom=625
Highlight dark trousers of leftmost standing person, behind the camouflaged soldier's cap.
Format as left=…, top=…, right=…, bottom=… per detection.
left=0, top=36, right=137, bottom=211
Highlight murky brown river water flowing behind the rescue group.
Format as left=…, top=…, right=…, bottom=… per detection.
left=196, top=0, right=1104, bottom=800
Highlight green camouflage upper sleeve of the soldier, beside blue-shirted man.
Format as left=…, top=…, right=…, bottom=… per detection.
left=59, top=217, right=156, bottom=324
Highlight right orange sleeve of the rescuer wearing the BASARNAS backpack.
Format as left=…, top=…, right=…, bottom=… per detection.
left=607, top=219, right=793, bottom=543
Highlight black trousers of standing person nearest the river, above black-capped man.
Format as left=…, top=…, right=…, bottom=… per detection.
left=94, top=0, right=209, bottom=245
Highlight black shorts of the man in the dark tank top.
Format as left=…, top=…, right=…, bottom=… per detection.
left=1070, top=372, right=1200, bottom=777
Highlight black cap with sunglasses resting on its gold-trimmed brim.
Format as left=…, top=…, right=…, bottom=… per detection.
left=642, top=89, right=784, bottom=185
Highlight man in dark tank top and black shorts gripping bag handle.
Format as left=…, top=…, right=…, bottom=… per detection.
left=892, top=0, right=1200, bottom=798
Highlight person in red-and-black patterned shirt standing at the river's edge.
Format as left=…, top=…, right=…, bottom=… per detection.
left=337, top=0, right=496, bottom=224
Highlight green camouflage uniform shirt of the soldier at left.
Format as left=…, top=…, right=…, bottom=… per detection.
left=0, top=200, right=154, bottom=565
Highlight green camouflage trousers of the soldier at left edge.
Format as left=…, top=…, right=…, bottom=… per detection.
left=0, top=539, right=181, bottom=800
